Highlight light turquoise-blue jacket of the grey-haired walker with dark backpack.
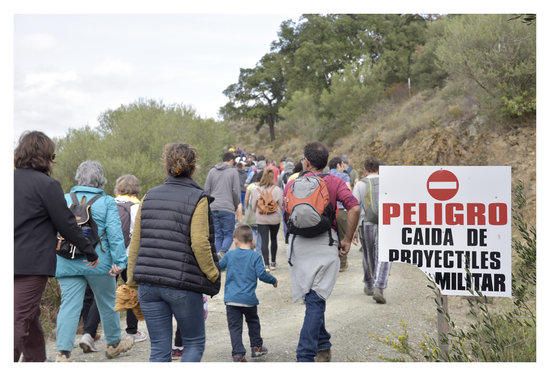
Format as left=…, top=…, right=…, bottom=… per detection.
left=55, top=185, right=128, bottom=278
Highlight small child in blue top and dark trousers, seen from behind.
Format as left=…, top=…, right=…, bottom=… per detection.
left=220, top=225, right=277, bottom=362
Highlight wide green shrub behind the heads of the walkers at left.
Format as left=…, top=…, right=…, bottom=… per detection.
left=54, top=100, right=233, bottom=194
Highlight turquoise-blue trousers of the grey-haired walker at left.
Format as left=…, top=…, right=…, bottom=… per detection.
left=56, top=274, right=120, bottom=351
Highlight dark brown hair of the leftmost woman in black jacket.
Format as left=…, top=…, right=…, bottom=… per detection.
left=13, top=131, right=55, bottom=175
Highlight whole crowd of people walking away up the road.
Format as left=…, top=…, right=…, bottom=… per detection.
left=14, top=132, right=389, bottom=362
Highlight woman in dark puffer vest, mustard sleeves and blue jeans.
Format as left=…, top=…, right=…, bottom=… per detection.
left=127, top=143, right=220, bottom=362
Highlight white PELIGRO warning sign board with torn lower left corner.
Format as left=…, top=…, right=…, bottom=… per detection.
left=378, top=166, right=512, bottom=297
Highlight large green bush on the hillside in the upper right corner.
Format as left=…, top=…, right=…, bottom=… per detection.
left=435, top=15, right=536, bottom=116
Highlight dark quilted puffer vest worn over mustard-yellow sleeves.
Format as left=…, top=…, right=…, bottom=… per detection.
left=134, top=177, right=220, bottom=296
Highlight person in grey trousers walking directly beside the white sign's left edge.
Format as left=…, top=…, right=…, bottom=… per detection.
left=353, top=158, right=391, bottom=304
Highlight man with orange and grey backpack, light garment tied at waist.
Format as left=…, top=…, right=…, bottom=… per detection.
left=284, top=142, right=359, bottom=362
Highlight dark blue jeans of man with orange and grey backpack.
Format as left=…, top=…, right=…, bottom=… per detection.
left=296, top=290, right=332, bottom=362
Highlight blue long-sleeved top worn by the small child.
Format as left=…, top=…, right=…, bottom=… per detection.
left=220, top=248, right=277, bottom=305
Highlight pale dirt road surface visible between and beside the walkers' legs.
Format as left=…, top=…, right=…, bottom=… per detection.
left=47, top=241, right=446, bottom=362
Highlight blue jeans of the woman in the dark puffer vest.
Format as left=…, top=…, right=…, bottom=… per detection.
left=138, top=284, right=206, bottom=362
